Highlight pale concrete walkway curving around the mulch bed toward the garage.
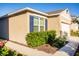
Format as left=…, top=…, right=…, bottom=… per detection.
left=5, top=37, right=79, bottom=56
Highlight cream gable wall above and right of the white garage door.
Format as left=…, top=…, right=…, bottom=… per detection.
left=60, top=9, right=72, bottom=36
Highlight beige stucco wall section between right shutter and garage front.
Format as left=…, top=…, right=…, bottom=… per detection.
left=48, top=16, right=60, bottom=36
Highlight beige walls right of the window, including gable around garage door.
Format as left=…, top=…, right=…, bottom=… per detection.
left=48, top=10, right=72, bottom=36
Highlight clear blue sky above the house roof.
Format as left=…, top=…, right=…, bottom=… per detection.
left=0, top=3, right=79, bottom=16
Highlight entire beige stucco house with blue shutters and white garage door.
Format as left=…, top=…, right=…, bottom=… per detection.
left=0, top=8, right=71, bottom=44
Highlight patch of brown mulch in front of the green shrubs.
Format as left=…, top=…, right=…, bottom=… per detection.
left=36, top=44, right=58, bottom=54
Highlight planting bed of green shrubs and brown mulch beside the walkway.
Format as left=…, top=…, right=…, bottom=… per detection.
left=26, top=31, right=68, bottom=54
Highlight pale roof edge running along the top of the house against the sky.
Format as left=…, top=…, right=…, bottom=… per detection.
left=0, top=7, right=68, bottom=18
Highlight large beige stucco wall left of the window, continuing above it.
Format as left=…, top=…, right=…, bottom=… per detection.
left=9, top=12, right=46, bottom=44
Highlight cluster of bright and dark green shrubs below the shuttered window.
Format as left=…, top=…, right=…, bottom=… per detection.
left=26, top=31, right=67, bottom=48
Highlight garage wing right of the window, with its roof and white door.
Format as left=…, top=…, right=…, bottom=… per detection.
left=48, top=9, right=72, bottom=36
